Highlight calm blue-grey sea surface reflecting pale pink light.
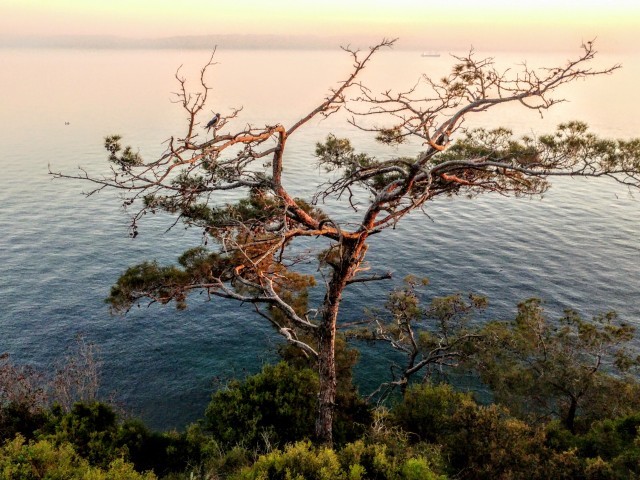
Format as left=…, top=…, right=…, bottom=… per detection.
left=0, top=50, right=640, bottom=428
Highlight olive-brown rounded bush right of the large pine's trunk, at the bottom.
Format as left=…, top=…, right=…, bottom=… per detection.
left=391, top=384, right=592, bottom=480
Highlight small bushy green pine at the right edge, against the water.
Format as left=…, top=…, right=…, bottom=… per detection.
left=475, top=299, right=640, bottom=431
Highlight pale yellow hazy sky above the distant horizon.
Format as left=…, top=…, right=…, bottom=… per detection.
left=0, top=0, right=640, bottom=51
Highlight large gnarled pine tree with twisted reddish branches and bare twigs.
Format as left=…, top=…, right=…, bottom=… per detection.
left=54, top=40, right=640, bottom=443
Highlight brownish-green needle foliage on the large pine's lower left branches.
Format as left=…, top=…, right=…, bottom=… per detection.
left=106, top=188, right=323, bottom=318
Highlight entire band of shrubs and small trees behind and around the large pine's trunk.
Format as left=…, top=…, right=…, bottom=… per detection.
left=0, top=290, right=640, bottom=480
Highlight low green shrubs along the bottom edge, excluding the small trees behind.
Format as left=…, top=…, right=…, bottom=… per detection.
left=5, top=363, right=640, bottom=480
